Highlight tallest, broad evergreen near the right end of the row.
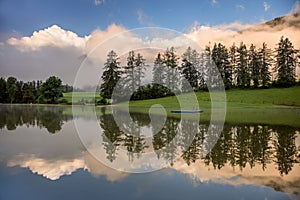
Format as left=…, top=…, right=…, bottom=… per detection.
left=275, top=37, right=297, bottom=87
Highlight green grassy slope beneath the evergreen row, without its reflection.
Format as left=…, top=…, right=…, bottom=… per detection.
left=130, top=86, right=300, bottom=107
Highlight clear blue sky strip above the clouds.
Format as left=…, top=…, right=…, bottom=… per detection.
left=0, top=0, right=295, bottom=37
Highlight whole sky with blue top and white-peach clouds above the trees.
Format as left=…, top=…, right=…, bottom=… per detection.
left=0, top=0, right=300, bottom=84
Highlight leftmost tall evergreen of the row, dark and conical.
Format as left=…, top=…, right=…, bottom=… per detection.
left=100, top=51, right=120, bottom=99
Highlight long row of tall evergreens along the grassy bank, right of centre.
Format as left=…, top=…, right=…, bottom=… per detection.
left=100, top=37, right=299, bottom=99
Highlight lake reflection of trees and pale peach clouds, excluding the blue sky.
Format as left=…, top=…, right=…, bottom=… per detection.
left=0, top=105, right=300, bottom=197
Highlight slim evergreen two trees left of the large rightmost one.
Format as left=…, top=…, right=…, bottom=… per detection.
left=248, top=44, right=261, bottom=88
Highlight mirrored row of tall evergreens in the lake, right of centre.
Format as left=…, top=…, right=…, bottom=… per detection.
left=99, top=109, right=300, bottom=177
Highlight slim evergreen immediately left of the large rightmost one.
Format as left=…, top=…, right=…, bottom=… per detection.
left=259, top=43, right=272, bottom=87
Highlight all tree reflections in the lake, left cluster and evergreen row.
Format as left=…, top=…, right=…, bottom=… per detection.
left=0, top=105, right=300, bottom=175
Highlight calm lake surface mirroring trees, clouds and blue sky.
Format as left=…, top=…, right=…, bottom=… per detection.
left=0, top=105, right=300, bottom=200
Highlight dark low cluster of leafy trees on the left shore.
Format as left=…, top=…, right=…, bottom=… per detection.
left=0, top=76, right=65, bottom=104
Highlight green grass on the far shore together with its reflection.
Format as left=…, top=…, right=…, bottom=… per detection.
left=63, top=86, right=300, bottom=127
